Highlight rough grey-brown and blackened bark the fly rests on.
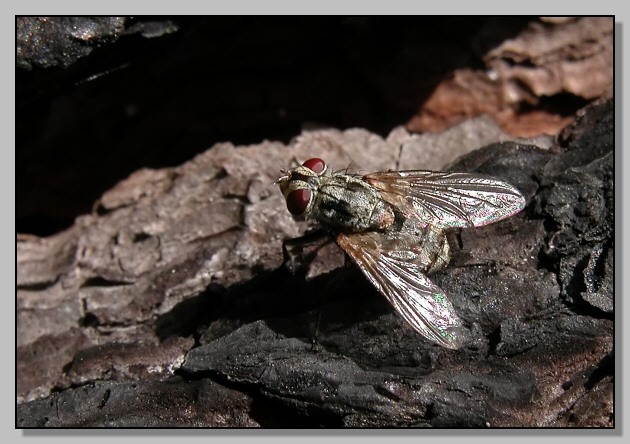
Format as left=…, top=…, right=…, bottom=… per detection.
left=18, top=101, right=614, bottom=427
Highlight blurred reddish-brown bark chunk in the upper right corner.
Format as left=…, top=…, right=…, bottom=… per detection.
left=408, top=17, right=614, bottom=137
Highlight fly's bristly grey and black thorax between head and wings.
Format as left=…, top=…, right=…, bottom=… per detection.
left=310, top=174, right=394, bottom=232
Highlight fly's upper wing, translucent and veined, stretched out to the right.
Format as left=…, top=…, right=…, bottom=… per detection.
left=363, top=171, right=525, bottom=228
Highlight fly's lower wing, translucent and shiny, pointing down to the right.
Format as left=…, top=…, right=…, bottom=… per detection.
left=336, top=232, right=462, bottom=349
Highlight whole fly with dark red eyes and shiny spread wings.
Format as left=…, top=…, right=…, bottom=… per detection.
left=276, top=158, right=525, bottom=349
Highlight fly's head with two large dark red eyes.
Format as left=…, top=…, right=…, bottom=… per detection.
left=276, top=157, right=328, bottom=219
